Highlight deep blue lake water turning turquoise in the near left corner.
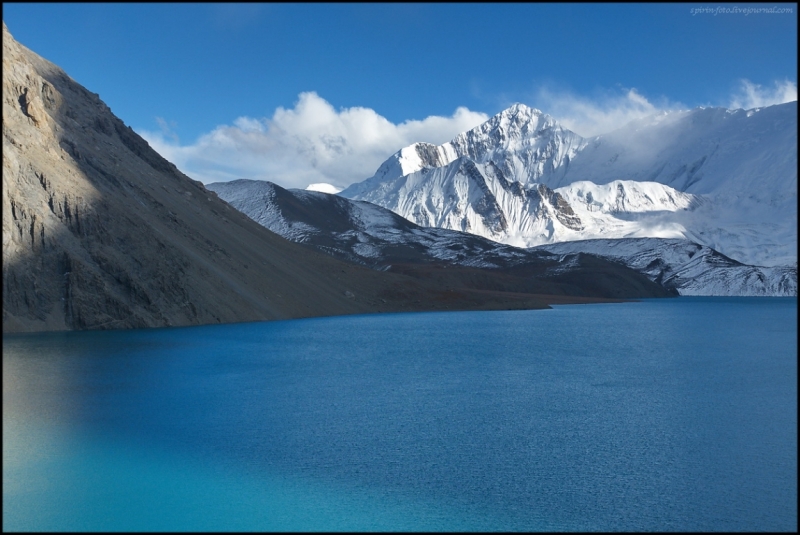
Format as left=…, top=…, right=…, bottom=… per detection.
left=3, top=297, right=797, bottom=531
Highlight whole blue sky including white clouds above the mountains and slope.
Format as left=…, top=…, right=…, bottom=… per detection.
left=3, top=3, right=797, bottom=187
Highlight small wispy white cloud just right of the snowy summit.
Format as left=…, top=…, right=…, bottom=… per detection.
left=533, top=87, right=681, bottom=137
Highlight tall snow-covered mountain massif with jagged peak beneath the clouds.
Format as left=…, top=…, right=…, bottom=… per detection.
left=341, top=102, right=797, bottom=266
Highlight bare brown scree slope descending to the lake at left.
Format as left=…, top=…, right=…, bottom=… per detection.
left=2, top=23, right=668, bottom=333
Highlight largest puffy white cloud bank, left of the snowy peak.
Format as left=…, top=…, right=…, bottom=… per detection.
left=139, top=92, right=488, bottom=188
